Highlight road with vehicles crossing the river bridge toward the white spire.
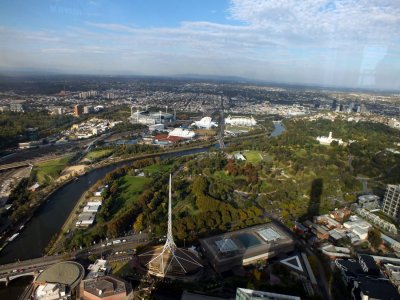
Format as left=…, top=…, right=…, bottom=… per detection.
left=0, top=233, right=150, bottom=281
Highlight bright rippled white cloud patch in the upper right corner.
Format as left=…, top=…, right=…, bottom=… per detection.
left=229, top=0, right=400, bottom=43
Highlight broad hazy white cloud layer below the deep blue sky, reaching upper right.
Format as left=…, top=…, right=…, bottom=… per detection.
left=0, top=0, right=400, bottom=88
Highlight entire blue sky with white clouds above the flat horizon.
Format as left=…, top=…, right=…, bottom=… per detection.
left=0, top=0, right=400, bottom=90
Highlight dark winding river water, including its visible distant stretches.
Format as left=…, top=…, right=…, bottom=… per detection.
left=0, top=122, right=285, bottom=299
